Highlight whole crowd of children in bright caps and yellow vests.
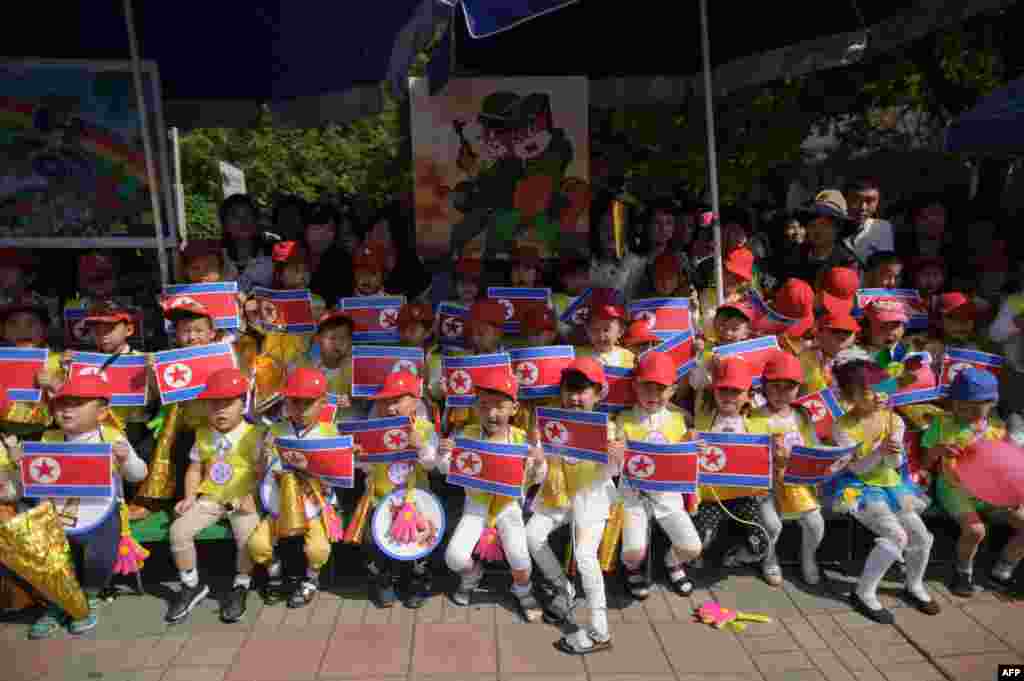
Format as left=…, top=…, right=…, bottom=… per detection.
left=0, top=192, right=1024, bottom=654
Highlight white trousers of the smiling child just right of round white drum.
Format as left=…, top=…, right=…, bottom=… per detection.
left=444, top=498, right=530, bottom=574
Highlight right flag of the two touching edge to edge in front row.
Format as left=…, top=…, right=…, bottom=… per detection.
left=697, top=432, right=772, bottom=490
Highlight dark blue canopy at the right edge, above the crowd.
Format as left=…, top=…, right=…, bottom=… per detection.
left=945, top=78, right=1024, bottom=156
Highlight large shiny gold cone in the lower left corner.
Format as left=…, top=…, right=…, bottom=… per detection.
left=0, top=501, right=89, bottom=620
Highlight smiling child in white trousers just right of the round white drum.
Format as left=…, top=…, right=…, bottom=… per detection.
left=436, top=368, right=544, bottom=621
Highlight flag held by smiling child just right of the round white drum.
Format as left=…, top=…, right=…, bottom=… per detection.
left=447, top=437, right=529, bottom=499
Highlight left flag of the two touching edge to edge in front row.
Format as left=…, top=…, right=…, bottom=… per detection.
left=623, top=440, right=699, bottom=494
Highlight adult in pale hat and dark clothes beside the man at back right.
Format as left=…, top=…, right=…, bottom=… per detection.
left=790, top=189, right=862, bottom=288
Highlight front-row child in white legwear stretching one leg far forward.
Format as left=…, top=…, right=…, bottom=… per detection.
left=526, top=357, right=625, bottom=654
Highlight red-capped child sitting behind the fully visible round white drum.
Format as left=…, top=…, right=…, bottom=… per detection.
left=357, top=371, right=437, bottom=609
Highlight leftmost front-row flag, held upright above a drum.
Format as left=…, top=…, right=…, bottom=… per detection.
left=18, top=442, right=115, bottom=499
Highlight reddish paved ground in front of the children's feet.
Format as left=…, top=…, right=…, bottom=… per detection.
left=0, top=572, right=1024, bottom=681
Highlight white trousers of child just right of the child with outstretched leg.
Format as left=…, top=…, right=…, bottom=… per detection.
left=623, top=491, right=700, bottom=566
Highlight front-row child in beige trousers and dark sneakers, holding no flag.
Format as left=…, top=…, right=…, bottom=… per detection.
left=166, top=369, right=266, bottom=623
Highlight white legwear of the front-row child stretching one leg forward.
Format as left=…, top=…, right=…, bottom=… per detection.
left=526, top=506, right=607, bottom=610
